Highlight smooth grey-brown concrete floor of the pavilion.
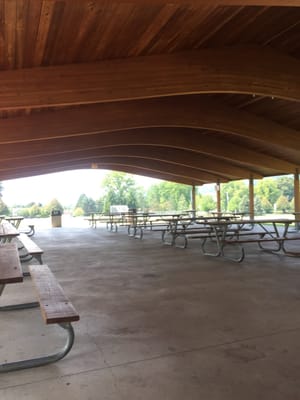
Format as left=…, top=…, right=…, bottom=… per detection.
left=0, top=226, right=300, bottom=400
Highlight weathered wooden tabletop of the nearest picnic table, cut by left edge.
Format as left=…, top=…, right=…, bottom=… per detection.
left=0, top=243, right=23, bottom=285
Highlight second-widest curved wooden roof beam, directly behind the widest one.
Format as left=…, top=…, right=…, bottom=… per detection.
left=0, top=97, right=300, bottom=154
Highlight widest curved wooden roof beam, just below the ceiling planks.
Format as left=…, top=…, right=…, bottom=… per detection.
left=0, top=47, right=300, bottom=110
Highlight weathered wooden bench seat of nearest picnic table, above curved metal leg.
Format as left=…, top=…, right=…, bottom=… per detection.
left=29, top=264, right=79, bottom=324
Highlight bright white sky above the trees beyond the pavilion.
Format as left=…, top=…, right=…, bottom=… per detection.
left=2, top=169, right=161, bottom=207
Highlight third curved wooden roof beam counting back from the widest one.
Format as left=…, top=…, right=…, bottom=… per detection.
left=1, top=128, right=295, bottom=173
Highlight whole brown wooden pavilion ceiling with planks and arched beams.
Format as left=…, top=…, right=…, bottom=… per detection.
left=0, top=0, right=300, bottom=185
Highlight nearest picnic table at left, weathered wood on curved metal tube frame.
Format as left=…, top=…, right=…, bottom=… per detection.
left=0, top=243, right=79, bottom=372
